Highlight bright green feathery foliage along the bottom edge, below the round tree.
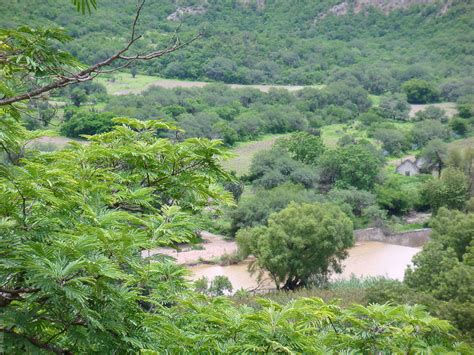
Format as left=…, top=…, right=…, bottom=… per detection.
left=159, top=298, right=470, bottom=354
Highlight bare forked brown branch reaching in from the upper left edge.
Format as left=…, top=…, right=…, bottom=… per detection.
left=0, top=0, right=201, bottom=106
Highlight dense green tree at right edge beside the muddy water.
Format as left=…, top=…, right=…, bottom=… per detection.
left=405, top=208, right=474, bottom=332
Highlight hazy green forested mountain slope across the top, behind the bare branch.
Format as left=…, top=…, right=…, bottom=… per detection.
left=0, top=0, right=474, bottom=87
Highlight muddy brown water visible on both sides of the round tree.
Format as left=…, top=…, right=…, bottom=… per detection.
left=189, top=242, right=421, bottom=290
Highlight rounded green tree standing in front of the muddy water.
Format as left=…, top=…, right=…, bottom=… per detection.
left=237, top=203, right=353, bottom=290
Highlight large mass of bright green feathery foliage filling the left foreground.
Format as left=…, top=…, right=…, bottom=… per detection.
left=0, top=119, right=235, bottom=353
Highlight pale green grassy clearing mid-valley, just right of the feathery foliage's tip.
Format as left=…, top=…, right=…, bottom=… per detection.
left=222, top=134, right=286, bottom=176
